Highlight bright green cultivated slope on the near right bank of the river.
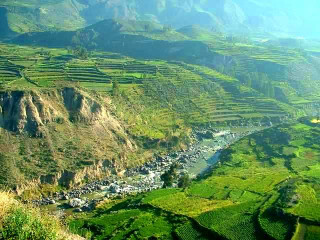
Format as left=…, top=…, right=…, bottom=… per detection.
left=70, top=118, right=320, bottom=240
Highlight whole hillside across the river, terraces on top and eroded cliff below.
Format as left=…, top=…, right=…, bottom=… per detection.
left=0, top=42, right=303, bottom=196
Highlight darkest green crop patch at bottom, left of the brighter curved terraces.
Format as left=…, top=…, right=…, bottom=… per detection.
left=70, top=197, right=188, bottom=239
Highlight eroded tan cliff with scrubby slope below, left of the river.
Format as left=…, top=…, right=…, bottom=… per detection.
left=0, top=88, right=137, bottom=188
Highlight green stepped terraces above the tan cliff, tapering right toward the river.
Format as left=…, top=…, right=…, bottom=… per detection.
left=0, top=45, right=295, bottom=131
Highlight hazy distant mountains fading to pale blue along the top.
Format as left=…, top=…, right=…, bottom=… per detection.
left=0, top=0, right=320, bottom=37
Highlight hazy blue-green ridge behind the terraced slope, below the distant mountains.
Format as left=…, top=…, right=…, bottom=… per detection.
left=10, top=19, right=320, bottom=105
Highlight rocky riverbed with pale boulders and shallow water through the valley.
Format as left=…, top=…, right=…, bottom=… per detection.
left=33, top=128, right=266, bottom=212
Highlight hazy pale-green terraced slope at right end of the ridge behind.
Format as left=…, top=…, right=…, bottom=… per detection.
left=204, top=39, right=319, bottom=104
